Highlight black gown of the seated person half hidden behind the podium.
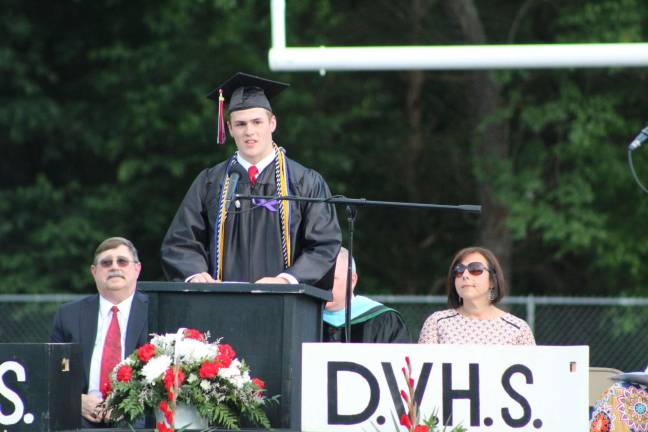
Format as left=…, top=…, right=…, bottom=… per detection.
left=323, top=305, right=412, bottom=343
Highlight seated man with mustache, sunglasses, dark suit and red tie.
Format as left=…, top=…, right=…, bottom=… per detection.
left=49, top=237, right=148, bottom=428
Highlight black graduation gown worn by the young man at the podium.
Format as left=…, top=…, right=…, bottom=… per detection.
left=161, top=158, right=341, bottom=289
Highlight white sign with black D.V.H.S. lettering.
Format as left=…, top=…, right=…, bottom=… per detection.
left=302, top=343, right=589, bottom=432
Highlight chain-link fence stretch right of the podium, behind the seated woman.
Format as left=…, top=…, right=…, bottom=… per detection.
left=372, top=295, right=648, bottom=371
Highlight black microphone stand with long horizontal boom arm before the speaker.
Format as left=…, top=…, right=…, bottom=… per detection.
left=235, top=194, right=481, bottom=343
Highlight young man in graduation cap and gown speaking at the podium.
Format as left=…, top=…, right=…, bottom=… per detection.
left=161, top=72, right=341, bottom=289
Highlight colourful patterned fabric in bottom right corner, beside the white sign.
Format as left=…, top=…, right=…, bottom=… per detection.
left=590, top=382, right=648, bottom=432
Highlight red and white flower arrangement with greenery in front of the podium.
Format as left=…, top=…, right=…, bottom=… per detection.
left=102, top=329, right=275, bottom=432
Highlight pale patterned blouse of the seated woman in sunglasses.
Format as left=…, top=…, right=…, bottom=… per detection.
left=419, top=309, right=535, bottom=345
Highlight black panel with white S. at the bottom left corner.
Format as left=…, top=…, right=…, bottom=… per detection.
left=0, top=343, right=83, bottom=432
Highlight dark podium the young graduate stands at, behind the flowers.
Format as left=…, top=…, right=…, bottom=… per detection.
left=138, top=282, right=332, bottom=430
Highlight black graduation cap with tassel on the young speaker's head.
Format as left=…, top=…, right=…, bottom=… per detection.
left=207, top=72, right=290, bottom=144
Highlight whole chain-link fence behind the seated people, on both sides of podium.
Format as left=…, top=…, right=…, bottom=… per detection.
left=0, top=294, right=648, bottom=371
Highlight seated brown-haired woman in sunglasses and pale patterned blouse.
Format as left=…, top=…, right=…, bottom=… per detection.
left=418, top=247, right=535, bottom=345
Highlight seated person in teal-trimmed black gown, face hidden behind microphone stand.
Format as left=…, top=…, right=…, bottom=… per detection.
left=324, top=248, right=411, bottom=343
